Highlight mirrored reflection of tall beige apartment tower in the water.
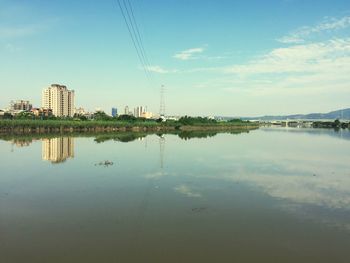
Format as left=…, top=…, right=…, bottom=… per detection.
left=42, top=137, right=74, bottom=163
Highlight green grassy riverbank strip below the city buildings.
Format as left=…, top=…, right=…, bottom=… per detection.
left=0, top=120, right=259, bottom=134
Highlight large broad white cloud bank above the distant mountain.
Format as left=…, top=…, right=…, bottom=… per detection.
left=222, top=38, right=350, bottom=95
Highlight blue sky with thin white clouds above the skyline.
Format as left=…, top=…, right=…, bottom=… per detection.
left=0, top=0, right=350, bottom=116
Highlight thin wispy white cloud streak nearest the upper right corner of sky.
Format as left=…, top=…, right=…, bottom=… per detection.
left=278, top=16, right=350, bottom=44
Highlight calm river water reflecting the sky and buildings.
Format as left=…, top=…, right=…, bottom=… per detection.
left=0, top=128, right=350, bottom=263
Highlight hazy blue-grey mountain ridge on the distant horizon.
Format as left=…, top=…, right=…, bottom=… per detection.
left=241, top=108, right=350, bottom=121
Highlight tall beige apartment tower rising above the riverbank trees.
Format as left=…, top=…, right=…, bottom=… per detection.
left=42, top=84, right=74, bottom=117
